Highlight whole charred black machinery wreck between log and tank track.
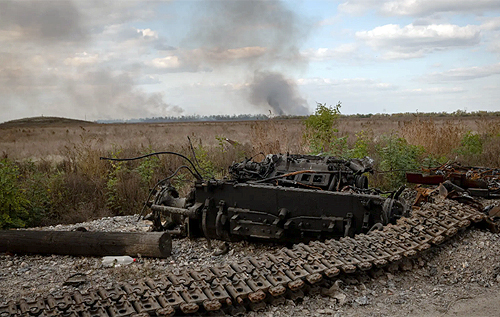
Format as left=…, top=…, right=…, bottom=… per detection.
left=149, top=154, right=406, bottom=242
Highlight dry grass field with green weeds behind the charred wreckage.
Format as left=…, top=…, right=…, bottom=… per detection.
left=0, top=115, right=500, bottom=227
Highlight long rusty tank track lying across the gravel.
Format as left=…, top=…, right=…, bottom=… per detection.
left=0, top=200, right=484, bottom=317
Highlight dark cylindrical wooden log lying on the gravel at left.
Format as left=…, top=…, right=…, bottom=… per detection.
left=0, top=230, right=172, bottom=258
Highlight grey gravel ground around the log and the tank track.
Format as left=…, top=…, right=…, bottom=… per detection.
left=0, top=201, right=500, bottom=316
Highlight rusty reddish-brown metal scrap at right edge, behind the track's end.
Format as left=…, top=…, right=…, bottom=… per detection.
left=406, top=162, right=500, bottom=198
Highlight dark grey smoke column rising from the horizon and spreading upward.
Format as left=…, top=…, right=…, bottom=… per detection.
left=188, top=1, right=311, bottom=115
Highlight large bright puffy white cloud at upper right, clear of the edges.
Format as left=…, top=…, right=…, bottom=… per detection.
left=356, top=24, right=481, bottom=59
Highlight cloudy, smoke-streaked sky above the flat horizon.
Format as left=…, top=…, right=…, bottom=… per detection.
left=0, top=0, right=500, bottom=122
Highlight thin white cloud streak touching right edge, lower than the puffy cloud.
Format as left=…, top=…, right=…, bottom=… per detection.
left=423, top=63, right=500, bottom=81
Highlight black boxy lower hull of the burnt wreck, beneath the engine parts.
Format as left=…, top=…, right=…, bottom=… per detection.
left=151, top=181, right=405, bottom=243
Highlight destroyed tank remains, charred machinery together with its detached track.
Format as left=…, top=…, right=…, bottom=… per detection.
left=0, top=152, right=492, bottom=317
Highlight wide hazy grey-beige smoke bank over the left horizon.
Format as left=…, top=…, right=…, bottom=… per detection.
left=0, top=0, right=183, bottom=119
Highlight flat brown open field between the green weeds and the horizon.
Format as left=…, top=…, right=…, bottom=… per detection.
left=0, top=116, right=500, bottom=161
